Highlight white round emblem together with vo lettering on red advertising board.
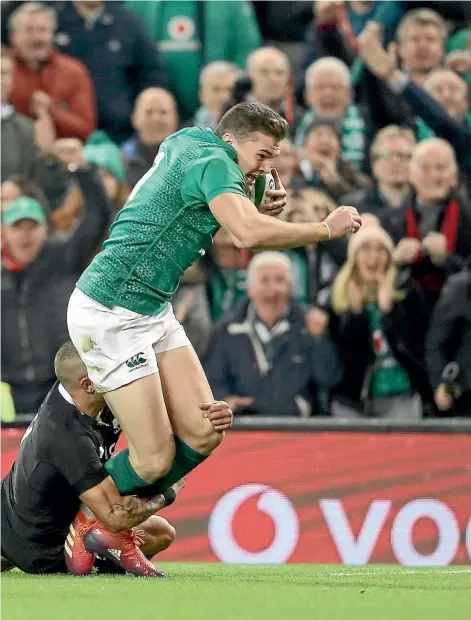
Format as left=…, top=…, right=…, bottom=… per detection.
left=208, top=484, right=471, bottom=566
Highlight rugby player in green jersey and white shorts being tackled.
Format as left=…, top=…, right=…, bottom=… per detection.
left=67, top=102, right=361, bottom=552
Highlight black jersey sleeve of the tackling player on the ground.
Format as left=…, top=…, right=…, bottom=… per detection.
left=51, top=435, right=108, bottom=495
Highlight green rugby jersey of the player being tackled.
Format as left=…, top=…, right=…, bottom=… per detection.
left=77, top=127, right=247, bottom=315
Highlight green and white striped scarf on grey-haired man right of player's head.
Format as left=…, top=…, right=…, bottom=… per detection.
left=294, top=103, right=366, bottom=169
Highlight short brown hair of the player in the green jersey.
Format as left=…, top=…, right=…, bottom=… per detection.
left=214, top=101, right=288, bottom=142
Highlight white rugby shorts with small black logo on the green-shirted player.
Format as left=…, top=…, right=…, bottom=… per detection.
left=67, top=288, right=190, bottom=392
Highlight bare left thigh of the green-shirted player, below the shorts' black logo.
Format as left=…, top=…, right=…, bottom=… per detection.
left=104, top=373, right=174, bottom=466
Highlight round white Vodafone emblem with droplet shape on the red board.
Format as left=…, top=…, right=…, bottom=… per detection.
left=208, top=484, right=299, bottom=564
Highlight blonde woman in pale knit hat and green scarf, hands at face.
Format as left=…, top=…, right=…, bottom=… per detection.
left=331, top=218, right=429, bottom=420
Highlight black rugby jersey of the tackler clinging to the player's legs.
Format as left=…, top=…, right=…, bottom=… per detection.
left=1, top=382, right=120, bottom=573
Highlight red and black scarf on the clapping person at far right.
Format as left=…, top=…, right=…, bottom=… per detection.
left=406, top=200, right=460, bottom=293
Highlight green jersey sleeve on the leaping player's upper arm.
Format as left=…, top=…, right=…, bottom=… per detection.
left=182, top=156, right=247, bottom=204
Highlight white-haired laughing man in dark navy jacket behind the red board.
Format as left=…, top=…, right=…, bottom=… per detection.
left=205, top=252, right=342, bottom=417
